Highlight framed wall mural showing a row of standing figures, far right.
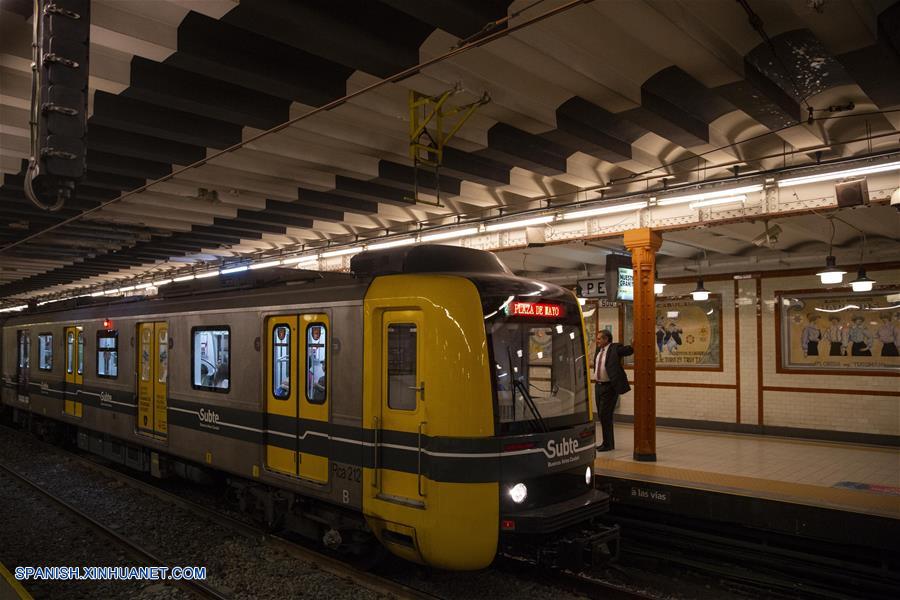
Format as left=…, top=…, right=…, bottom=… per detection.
left=776, top=289, right=900, bottom=371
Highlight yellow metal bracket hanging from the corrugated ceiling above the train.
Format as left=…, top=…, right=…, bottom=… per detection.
left=409, top=84, right=491, bottom=206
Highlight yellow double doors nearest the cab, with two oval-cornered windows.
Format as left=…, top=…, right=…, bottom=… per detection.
left=266, top=313, right=330, bottom=483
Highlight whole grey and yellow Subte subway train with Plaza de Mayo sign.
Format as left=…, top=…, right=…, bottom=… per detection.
left=2, top=245, right=617, bottom=570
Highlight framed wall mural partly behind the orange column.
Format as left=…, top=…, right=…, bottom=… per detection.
left=622, top=294, right=722, bottom=370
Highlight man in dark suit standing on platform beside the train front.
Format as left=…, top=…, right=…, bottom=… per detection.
left=594, top=329, right=634, bottom=452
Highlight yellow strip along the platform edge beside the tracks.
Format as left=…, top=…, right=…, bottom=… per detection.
left=594, top=458, right=900, bottom=519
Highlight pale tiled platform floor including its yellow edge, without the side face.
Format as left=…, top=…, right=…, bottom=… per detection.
left=596, top=423, right=900, bottom=519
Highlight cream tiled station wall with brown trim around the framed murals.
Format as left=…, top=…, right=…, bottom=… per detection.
left=597, top=269, right=900, bottom=436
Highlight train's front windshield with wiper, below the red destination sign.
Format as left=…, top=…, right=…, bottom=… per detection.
left=486, top=316, right=588, bottom=433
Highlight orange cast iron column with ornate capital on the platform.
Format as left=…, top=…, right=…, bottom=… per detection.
left=622, top=228, right=662, bottom=461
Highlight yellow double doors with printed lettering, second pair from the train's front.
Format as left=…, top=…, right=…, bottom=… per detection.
left=137, top=321, right=169, bottom=438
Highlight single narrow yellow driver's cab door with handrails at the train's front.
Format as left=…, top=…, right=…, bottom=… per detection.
left=374, top=310, right=428, bottom=508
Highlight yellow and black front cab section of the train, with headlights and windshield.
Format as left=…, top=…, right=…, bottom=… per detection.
left=352, top=247, right=617, bottom=569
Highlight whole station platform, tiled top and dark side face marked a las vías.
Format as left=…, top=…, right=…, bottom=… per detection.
left=595, top=423, right=900, bottom=551
